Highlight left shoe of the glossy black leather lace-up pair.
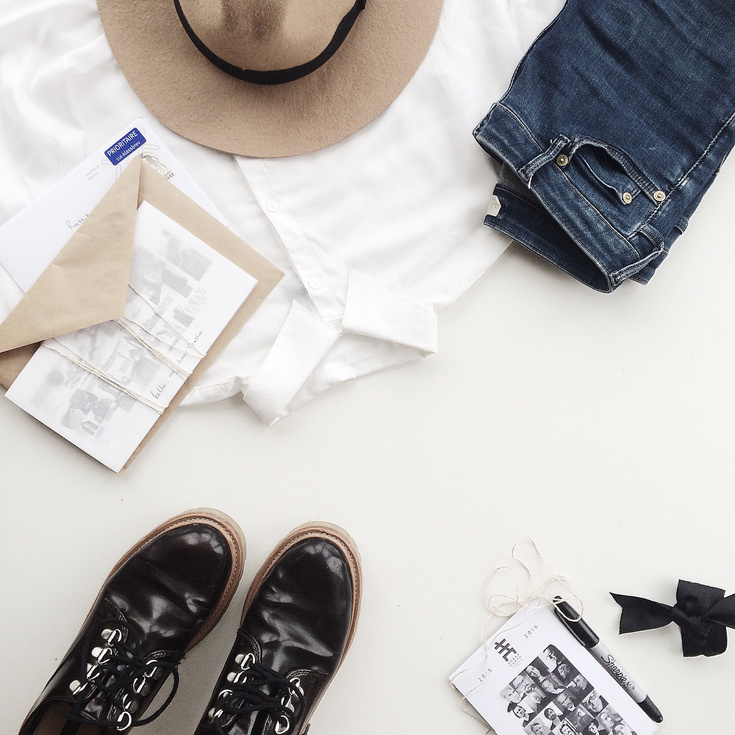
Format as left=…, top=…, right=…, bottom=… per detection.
left=20, top=509, right=245, bottom=735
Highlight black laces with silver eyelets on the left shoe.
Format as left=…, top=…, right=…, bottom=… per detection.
left=56, top=620, right=179, bottom=732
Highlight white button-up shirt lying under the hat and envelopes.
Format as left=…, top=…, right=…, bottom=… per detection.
left=0, top=0, right=563, bottom=424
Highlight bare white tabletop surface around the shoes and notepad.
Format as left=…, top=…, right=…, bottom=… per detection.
left=0, top=142, right=735, bottom=735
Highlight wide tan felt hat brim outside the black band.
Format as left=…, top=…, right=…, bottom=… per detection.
left=97, top=0, right=442, bottom=157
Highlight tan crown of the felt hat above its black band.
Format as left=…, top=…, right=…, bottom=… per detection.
left=180, top=0, right=362, bottom=71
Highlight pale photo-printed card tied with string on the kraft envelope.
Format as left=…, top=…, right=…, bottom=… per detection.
left=6, top=202, right=257, bottom=472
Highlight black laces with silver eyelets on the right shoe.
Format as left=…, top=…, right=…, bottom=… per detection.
left=208, top=653, right=304, bottom=735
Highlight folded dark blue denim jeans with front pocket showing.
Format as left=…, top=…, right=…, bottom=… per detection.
left=474, top=0, right=735, bottom=292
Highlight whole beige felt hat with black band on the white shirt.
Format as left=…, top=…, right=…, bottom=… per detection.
left=97, top=0, right=442, bottom=157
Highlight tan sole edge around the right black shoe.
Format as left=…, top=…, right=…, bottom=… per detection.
left=240, top=523, right=362, bottom=735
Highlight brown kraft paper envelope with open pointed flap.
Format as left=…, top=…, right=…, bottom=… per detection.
left=0, top=158, right=283, bottom=469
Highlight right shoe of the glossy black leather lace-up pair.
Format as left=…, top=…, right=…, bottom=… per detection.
left=195, top=524, right=362, bottom=735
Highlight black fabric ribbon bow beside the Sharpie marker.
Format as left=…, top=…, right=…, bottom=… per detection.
left=610, top=579, right=735, bottom=656
